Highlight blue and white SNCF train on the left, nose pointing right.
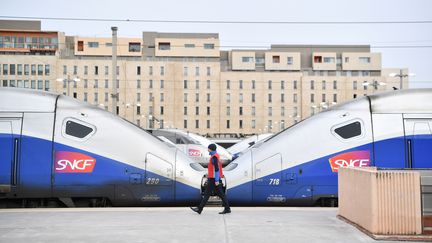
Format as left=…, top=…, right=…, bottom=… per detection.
left=0, top=88, right=204, bottom=207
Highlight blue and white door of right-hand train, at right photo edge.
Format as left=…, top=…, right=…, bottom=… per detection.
left=404, top=117, right=432, bottom=168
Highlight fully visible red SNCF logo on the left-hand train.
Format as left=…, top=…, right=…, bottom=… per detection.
left=55, top=151, right=96, bottom=173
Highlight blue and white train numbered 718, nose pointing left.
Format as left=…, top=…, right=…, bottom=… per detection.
left=224, top=89, right=432, bottom=205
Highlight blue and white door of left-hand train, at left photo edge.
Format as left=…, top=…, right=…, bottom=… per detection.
left=0, top=114, right=22, bottom=193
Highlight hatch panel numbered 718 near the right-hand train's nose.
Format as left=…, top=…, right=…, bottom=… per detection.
left=253, top=154, right=286, bottom=204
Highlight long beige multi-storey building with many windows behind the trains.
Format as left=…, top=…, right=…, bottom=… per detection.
left=0, top=21, right=408, bottom=136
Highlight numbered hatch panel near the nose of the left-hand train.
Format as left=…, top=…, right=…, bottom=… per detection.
left=144, top=153, right=175, bottom=203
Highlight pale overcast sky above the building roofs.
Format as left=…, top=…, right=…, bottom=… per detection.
left=0, top=0, right=432, bottom=88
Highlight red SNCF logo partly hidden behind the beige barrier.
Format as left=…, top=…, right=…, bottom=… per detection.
left=329, top=150, right=371, bottom=173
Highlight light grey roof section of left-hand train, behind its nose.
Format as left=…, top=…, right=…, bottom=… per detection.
left=0, top=87, right=59, bottom=112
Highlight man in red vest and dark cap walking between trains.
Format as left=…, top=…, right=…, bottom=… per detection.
left=191, top=144, right=231, bottom=214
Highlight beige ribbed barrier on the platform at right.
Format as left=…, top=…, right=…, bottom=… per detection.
left=338, top=167, right=422, bottom=235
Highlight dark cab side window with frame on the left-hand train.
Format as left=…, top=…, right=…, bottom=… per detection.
left=62, top=119, right=96, bottom=141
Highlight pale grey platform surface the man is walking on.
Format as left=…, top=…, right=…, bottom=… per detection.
left=0, top=207, right=422, bottom=243
